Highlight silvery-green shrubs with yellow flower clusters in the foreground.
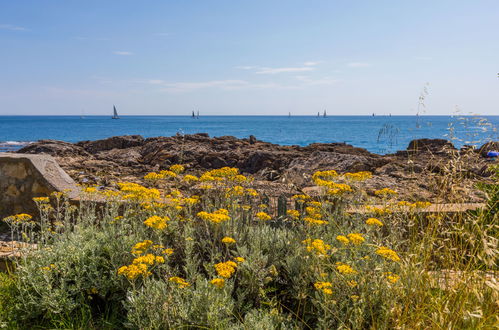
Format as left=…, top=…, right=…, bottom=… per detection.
left=0, top=165, right=497, bottom=329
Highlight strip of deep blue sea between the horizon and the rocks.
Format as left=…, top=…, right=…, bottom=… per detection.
left=0, top=116, right=499, bottom=154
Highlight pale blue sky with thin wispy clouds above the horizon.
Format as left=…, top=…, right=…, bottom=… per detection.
left=0, top=0, right=499, bottom=115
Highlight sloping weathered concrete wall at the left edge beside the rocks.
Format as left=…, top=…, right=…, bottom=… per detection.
left=0, top=153, right=79, bottom=219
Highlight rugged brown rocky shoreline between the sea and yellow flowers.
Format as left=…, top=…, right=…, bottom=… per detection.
left=17, top=133, right=499, bottom=202
